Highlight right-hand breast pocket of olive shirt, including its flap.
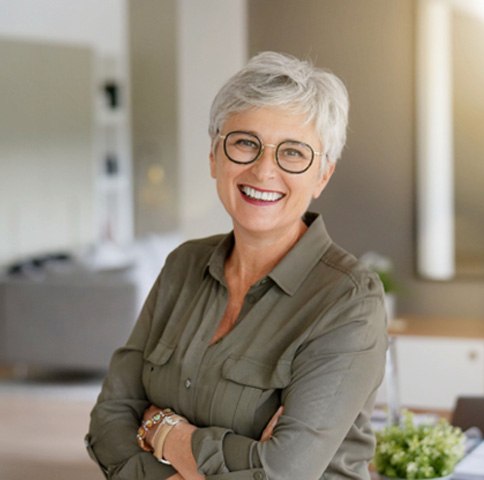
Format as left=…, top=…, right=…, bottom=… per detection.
left=214, top=355, right=291, bottom=438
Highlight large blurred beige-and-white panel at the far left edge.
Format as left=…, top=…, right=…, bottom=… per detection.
left=0, top=39, right=96, bottom=264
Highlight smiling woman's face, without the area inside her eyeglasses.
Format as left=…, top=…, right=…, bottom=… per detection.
left=210, top=107, right=334, bottom=239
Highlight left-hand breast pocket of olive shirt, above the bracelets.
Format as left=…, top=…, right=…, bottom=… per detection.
left=143, top=341, right=175, bottom=405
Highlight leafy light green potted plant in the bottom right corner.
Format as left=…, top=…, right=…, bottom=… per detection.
left=373, top=411, right=465, bottom=479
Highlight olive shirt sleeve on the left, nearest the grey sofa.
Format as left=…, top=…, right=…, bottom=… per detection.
left=85, top=278, right=180, bottom=480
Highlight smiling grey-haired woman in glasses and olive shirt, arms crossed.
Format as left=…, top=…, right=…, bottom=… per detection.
left=86, top=52, right=386, bottom=480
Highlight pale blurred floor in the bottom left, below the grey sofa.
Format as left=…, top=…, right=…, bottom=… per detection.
left=0, top=372, right=104, bottom=480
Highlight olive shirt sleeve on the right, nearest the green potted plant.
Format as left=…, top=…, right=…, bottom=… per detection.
left=192, top=280, right=387, bottom=480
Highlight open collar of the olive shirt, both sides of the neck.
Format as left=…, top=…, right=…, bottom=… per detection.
left=207, top=212, right=332, bottom=295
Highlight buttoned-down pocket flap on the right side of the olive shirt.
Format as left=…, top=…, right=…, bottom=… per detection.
left=222, top=356, right=291, bottom=389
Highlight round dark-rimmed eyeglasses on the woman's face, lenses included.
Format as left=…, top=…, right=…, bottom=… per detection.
left=219, top=131, right=322, bottom=173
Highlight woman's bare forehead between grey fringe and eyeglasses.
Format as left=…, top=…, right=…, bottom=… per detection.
left=221, top=107, right=319, bottom=144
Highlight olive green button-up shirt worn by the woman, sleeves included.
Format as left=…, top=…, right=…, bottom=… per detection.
left=86, top=213, right=387, bottom=480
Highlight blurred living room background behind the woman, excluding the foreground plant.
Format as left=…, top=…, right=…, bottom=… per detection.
left=0, top=0, right=484, bottom=480
